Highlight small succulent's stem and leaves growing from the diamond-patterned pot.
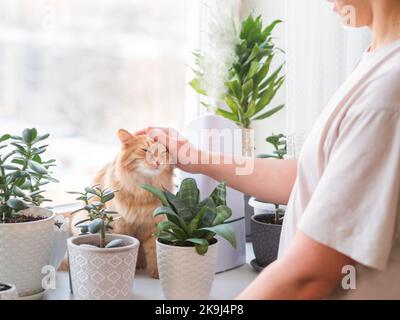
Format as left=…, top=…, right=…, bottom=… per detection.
left=68, top=185, right=124, bottom=248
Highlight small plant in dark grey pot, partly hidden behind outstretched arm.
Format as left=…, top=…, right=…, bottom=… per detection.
left=249, top=134, right=286, bottom=270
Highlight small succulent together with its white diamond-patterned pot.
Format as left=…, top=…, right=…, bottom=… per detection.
left=68, top=186, right=139, bottom=300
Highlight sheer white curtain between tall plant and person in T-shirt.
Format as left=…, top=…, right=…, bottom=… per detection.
left=286, top=0, right=370, bottom=158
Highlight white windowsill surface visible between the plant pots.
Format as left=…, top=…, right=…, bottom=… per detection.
left=43, top=243, right=258, bottom=300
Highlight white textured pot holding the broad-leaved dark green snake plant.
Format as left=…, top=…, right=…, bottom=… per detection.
left=157, top=241, right=218, bottom=300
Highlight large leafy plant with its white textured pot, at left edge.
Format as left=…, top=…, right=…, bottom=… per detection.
left=0, top=129, right=66, bottom=298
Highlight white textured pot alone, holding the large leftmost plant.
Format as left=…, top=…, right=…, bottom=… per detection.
left=0, top=207, right=55, bottom=297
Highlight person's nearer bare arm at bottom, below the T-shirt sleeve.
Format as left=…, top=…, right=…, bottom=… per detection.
left=237, top=231, right=355, bottom=300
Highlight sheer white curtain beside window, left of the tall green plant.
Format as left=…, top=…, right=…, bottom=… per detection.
left=185, top=0, right=243, bottom=124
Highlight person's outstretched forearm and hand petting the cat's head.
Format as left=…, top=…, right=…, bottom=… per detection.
left=135, top=128, right=297, bottom=204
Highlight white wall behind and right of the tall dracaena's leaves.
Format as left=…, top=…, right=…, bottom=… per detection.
left=242, top=0, right=286, bottom=154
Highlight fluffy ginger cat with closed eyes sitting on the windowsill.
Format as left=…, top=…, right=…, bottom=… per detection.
left=72, top=129, right=173, bottom=278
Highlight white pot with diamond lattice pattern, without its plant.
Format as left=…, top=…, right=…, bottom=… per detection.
left=68, top=234, right=139, bottom=300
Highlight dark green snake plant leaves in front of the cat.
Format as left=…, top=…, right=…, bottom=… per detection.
left=140, top=178, right=240, bottom=255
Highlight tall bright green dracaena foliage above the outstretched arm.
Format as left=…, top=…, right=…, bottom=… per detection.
left=190, top=14, right=284, bottom=128
